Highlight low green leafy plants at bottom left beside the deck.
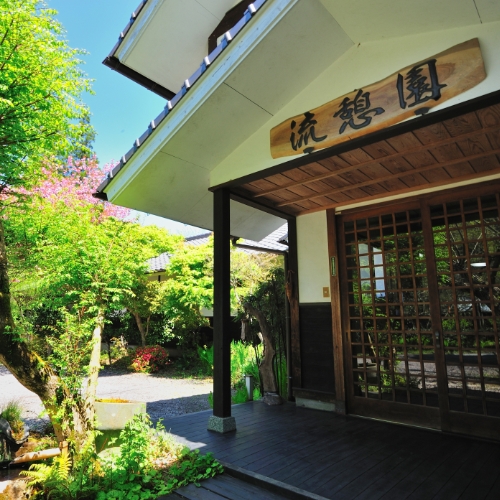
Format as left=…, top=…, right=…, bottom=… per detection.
left=24, top=414, right=223, bottom=500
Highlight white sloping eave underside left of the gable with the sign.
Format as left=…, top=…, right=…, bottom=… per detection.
left=105, top=0, right=352, bottom=240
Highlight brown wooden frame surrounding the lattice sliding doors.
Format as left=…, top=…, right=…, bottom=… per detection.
left=334, top=180, right=500, bottom=438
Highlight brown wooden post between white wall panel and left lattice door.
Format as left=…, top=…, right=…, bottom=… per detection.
left=326, top=209, right=346, bottom=414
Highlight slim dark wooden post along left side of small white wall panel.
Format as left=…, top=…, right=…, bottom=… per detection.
left=287, top=218, right=302, bottom=388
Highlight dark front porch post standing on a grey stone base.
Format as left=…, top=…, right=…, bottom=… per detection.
left=208, top=188, right=236, bottom=433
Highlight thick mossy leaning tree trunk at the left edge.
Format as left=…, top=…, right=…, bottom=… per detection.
left=0, top=219, right=64, bottom=441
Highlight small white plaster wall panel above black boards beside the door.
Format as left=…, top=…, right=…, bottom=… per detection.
left=297, top=211, right=330, bottom=304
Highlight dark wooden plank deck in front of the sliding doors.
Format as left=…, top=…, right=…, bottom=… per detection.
left=160, top=402, right=500, bottom=500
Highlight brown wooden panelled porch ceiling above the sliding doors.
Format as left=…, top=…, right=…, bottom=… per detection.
left=231, top=104, right=500, bottom=215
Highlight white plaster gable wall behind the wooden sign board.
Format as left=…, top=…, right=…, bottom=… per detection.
left=210, top=22, right=500, bottom=186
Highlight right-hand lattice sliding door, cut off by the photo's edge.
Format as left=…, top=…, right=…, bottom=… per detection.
left=431, top=194, right=500, bottom=420
